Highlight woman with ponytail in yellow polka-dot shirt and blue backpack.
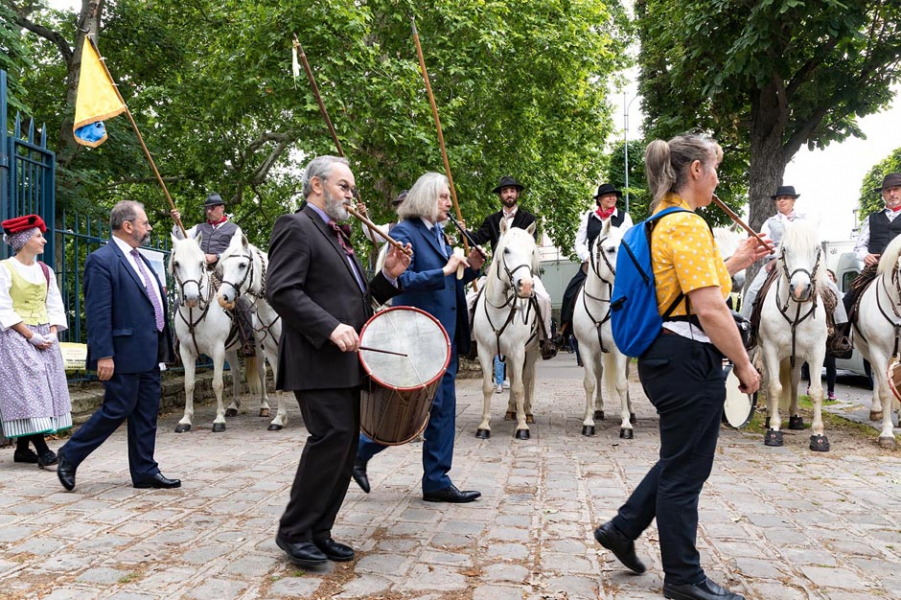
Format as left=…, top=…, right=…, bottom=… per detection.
left=594, top=135, right=767, bottom=600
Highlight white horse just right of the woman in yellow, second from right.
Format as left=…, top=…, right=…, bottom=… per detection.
left=758, top=221, right=829, bottom=452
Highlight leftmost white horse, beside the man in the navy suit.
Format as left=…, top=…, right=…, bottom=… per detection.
left=169, top=234, right=260, bottom=433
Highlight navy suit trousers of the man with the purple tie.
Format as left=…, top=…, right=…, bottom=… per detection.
left=59, top=367, right=160, bottom=483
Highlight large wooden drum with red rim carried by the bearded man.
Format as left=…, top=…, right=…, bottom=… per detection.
left=360, top=306, right=451, bottom=446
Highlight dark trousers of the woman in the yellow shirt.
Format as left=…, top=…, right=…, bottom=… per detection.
left=613, top=334, right=726, bottom=585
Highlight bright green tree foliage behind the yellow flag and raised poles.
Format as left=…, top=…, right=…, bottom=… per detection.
left=5, top=0, right=628, bottom=255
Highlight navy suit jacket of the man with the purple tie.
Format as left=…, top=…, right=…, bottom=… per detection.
left=84, top=240, right=172, bottom=373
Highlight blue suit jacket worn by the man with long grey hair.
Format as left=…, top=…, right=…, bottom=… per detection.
left=391, top=219, right=479, bottom=353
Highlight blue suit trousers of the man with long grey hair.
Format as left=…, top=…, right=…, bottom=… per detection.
left=357, top=343, right=458, bottom=494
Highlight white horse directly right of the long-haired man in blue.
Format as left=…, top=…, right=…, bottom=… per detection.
left=472, top=219, right=540, bottom=440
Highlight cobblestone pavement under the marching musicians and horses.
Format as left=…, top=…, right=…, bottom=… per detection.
left=0, top=354, right=901, bottom=600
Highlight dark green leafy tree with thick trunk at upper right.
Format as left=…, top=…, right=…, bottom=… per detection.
left=636, top=0, right=901, bottom=234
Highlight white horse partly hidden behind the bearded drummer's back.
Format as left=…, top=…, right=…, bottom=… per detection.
left=218, top=232, right=288, bottom=431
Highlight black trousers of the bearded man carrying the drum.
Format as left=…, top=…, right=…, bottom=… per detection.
left=279, top=387, right=360, bottom=542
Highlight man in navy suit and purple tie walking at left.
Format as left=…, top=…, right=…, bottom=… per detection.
left=56, top=200, right=181, bottom=490
